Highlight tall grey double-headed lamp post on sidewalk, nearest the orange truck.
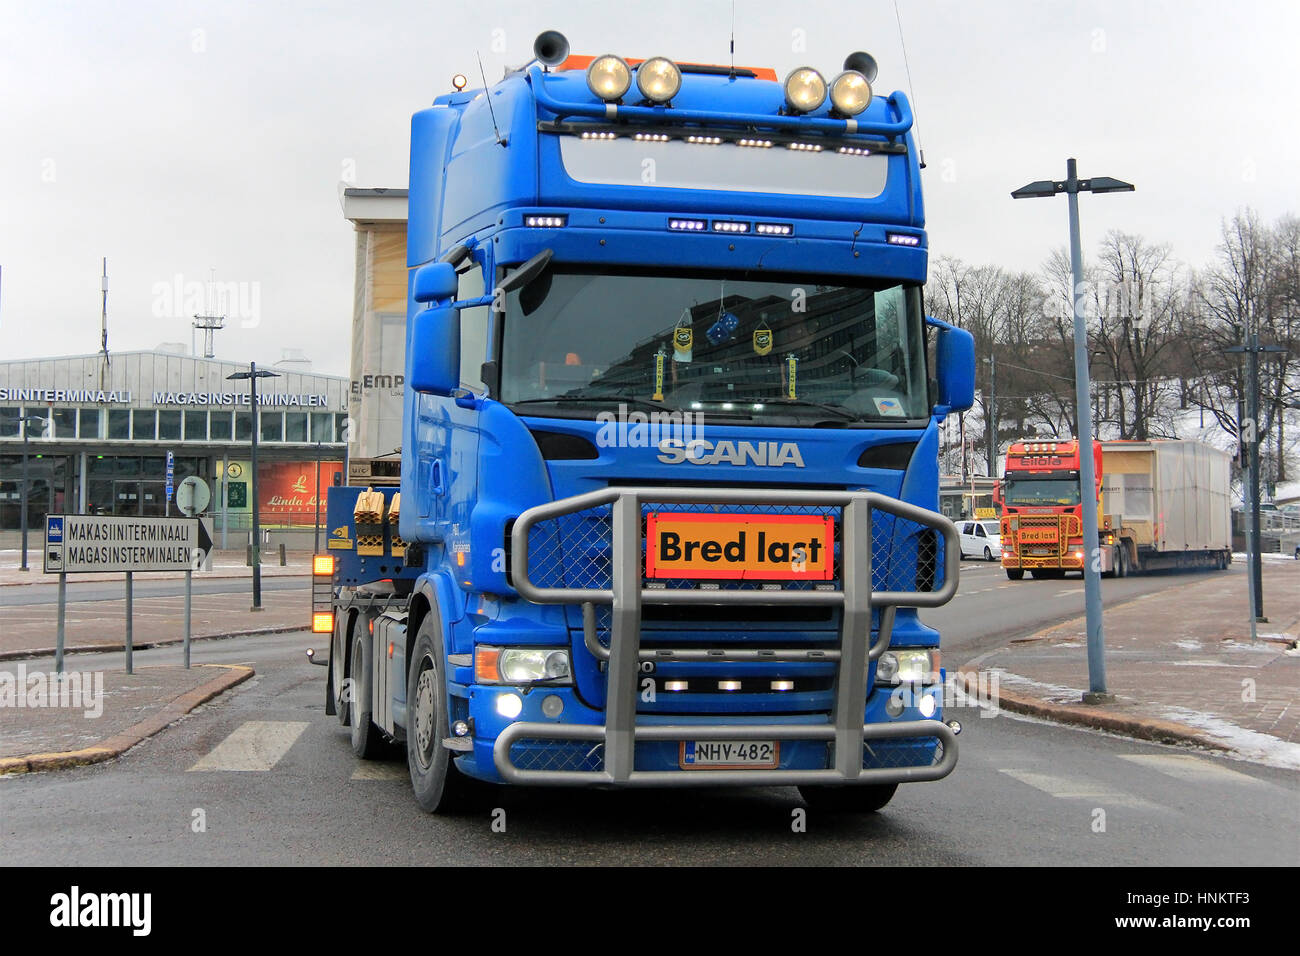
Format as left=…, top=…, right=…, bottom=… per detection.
left=1011, top=159, right=1134, bottom=704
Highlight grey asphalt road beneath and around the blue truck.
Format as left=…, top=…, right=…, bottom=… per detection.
left=0, top=567, right=1300, bottom=866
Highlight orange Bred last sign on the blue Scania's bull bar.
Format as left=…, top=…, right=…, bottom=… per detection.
left=646, top=512, right=835, bottom=580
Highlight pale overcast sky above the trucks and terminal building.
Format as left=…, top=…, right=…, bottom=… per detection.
left=0, top=0, right=1300, bottom=375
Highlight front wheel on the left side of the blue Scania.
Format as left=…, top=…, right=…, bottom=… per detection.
left=407, top=611, right=473, bottom=813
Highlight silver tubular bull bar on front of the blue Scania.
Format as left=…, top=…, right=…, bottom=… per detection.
left=493, top=486, right=961, bottom=787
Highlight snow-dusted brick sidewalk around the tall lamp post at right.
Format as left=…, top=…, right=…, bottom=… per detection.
left=961, top=555, right=1300, bottom=770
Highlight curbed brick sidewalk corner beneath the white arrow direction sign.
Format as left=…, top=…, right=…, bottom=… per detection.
left=0, top=663, right=254, bottom=774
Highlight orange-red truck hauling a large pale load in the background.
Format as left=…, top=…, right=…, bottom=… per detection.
left=996, top=440, right=1232, bottom=581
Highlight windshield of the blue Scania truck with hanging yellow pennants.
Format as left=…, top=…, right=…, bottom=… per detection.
left=501, top=269, right=928, bottom=424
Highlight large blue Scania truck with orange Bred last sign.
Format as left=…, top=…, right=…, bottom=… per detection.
left=313, top=33, right=974, bottom=812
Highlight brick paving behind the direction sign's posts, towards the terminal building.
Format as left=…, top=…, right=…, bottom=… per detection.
left=0, top=550, right=312, bottom=661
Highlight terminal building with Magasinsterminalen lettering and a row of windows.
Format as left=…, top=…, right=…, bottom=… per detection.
left=0, top=350, right=350, bottom=542
